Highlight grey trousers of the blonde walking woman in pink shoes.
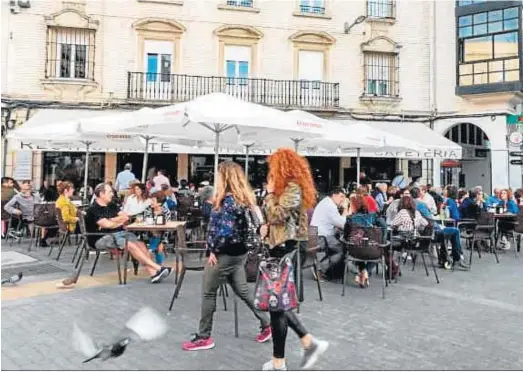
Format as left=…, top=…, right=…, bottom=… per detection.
left=198, top=254, right=270, bottom=338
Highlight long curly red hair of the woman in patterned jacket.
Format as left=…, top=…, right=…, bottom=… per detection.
left=267, top=148, right=317, bottom=209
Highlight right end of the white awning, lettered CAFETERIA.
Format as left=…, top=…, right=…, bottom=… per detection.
left=338, top=120, right=462, bottom=159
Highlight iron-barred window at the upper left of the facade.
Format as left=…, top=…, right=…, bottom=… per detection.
left=45, top=27, right=95, bottom=80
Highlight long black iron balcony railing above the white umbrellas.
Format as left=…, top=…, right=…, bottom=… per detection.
left=127, top=72, right=340, bottom=108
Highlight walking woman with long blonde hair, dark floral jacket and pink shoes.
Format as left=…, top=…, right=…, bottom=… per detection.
left=182, top=162, right=271, bottom=351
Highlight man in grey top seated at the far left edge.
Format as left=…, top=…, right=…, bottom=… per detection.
left=4, top=180, right=40, bottom=236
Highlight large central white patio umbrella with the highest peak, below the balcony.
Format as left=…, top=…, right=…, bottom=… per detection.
left=107, top=93, right=326, bottom=182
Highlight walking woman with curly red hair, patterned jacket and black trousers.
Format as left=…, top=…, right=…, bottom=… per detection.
left=261, top=149, right=329, bottom=370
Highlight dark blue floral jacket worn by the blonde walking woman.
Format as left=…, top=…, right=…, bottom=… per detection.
left=207, top=194, right=246, bottom=255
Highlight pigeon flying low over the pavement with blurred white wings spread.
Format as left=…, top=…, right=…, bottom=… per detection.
left=73, top=307, right=167, bottom=363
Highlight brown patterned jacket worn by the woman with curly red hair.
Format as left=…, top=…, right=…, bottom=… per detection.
left=265, top=182, right=309, bottom=248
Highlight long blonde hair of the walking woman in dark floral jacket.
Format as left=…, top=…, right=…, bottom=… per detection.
left=214, top=161, right=256, bottom=209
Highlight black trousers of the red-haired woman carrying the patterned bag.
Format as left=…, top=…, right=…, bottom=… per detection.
left=270, top=241, right=308, bottom=359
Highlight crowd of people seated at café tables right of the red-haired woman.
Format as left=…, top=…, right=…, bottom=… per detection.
left=310, top=181, right=523, bottom=286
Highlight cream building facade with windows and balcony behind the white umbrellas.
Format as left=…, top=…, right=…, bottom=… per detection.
left=2, top=0, right=523, bottom=188
